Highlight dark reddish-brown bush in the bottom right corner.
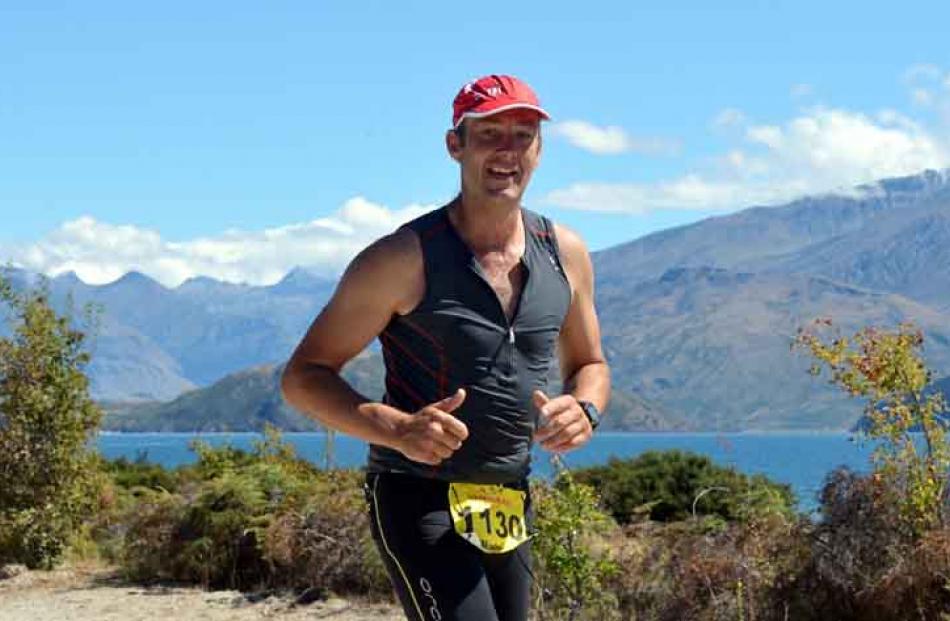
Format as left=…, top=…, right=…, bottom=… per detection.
left=779, top=468, right=950, bottom=621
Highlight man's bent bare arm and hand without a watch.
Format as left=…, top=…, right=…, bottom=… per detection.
left=281, top=229, right=468, bottom=464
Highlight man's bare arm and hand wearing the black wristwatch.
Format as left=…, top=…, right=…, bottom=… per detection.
left=535, top=225, right=610, bottom=452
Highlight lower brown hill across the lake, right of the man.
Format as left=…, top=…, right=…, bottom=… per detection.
left=598, top=268, right=950, bottom=430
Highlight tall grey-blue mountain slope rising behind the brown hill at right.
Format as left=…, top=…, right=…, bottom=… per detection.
left=594, top=171, right=950, bottom=300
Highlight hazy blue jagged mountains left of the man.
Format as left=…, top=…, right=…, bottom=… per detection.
left=0, top=269, right=336, bottom=401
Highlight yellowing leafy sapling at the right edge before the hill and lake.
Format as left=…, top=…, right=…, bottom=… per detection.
left=796, top=320, right=950, bottom=537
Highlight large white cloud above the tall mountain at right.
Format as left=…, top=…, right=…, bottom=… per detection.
left=541, top=107, right=950, bottom=214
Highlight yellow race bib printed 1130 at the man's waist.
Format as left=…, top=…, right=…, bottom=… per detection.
left=449, top=483, right=528, bottom=554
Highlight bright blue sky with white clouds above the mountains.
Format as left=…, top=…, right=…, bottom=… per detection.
left=0, top=0, right=950, bottom=287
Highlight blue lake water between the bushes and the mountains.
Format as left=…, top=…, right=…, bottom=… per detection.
left=97, top=432, right=872, bottom=512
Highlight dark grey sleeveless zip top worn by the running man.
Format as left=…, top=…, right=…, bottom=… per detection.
left=368, top=207, right=571, bottom=483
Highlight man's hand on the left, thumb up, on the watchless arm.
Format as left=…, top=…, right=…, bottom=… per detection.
left=395, top=388, right=468, bottom=466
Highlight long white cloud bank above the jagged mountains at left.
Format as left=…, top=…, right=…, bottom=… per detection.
left=0, top=196, right=432, bottom=287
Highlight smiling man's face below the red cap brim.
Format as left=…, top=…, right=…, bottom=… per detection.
left=446, top=109, right=541, bottom=204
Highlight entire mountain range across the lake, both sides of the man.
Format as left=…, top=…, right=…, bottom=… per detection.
left=10, top=171, right=950, bottom=430
